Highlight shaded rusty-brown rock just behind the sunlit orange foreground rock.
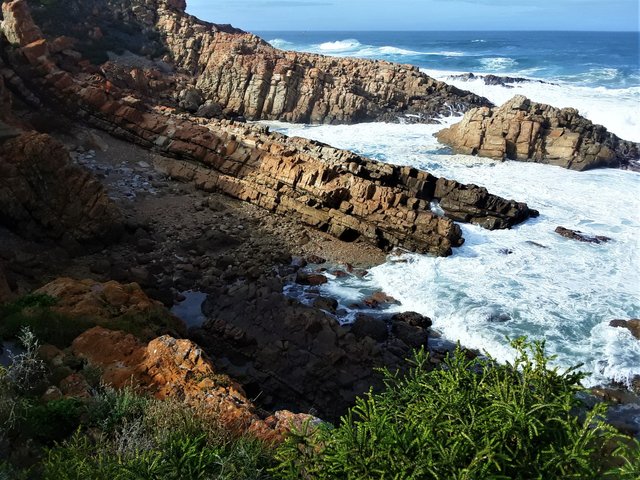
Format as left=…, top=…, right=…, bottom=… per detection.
left=35, top=278, right=186, bottom=338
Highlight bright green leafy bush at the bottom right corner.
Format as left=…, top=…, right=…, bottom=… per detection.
left=274, top=339, right=640, bottom=480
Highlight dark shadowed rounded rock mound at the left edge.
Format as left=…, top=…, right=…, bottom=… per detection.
left=0, top=132, right=122, bottom=244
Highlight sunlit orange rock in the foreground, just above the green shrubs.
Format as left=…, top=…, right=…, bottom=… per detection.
left=71, top=327, right=314, bottom=441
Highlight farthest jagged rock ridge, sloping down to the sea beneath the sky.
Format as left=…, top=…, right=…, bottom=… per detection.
left=22, top=0, right=490, bottom=123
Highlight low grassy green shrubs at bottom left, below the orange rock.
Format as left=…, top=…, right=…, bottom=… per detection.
left=42, top=389, right=273, bottom=480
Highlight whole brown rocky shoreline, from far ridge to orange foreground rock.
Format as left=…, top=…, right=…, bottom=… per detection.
left=0, top=0, right=635, bottom=464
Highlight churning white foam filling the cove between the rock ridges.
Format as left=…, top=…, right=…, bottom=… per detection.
left=270, top=119, right=640, bottom=384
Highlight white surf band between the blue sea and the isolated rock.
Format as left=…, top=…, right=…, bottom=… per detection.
left=423, top=69, right=640, bottom=142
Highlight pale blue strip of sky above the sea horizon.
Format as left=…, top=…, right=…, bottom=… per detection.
left=187, top=0, right=640, bottom=32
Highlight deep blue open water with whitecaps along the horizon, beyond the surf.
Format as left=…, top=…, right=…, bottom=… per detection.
left=258, top=32, right=640, bottom=88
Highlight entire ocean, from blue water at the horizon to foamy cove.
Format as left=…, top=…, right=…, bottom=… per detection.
left=259, top=32, right=640, bottom=385
